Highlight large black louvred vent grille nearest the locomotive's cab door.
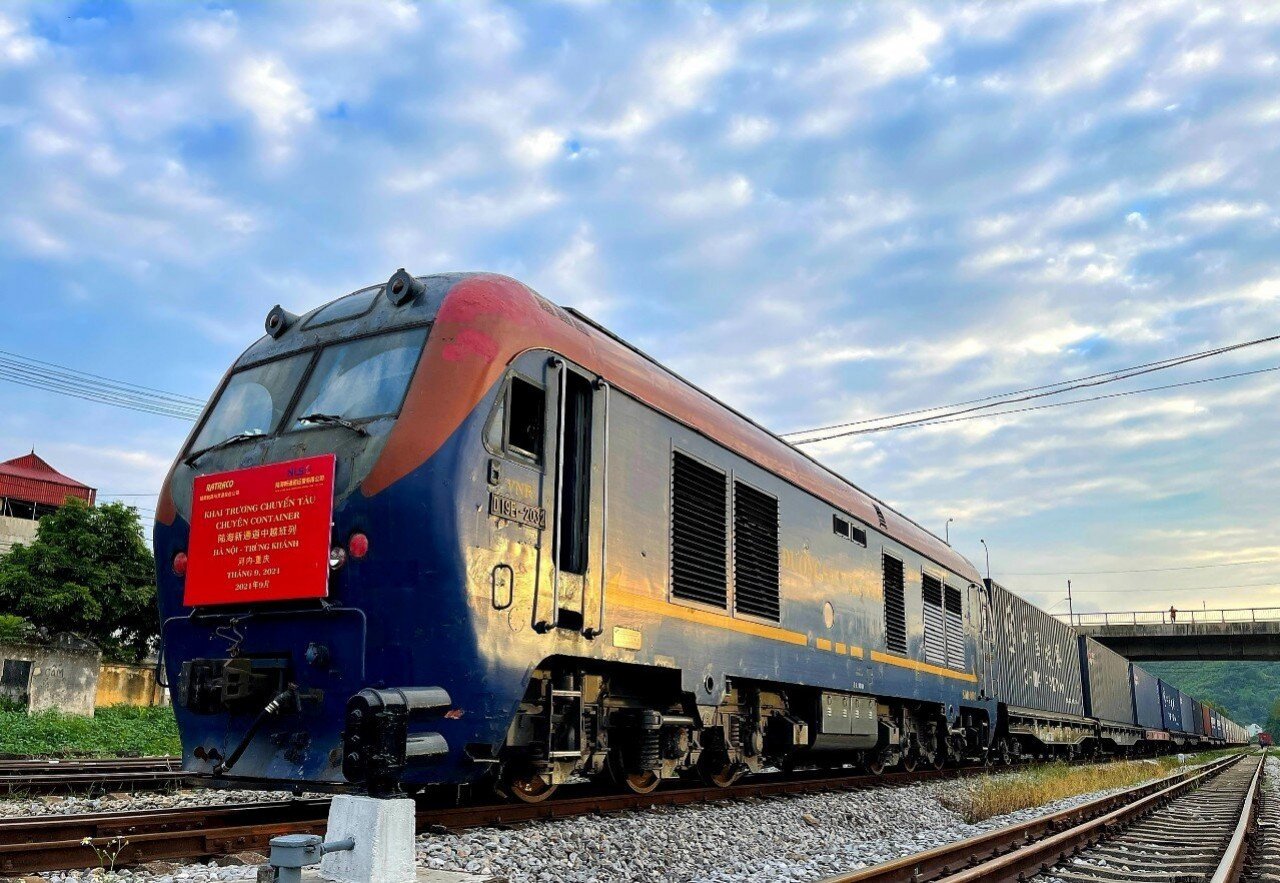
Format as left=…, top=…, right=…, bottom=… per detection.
left=671, top=450, right=728, bottom=607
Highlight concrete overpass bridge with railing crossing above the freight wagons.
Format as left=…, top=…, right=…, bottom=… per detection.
left=1061, top=607, right=1280, bottom=662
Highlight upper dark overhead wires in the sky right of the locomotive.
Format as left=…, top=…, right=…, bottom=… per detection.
left=782, top=334, right=1280, bottom=444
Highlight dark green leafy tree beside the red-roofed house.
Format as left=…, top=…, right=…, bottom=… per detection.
left=0, top=500, right=160, bottom=660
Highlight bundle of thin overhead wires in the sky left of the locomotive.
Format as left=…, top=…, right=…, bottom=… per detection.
left=0, top=349, right=205, bottom=420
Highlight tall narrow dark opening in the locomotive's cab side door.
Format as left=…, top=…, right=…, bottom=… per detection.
left=558, top=371, right=594, bottom=573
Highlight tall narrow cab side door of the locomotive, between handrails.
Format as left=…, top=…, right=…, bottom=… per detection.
left=535, top=357, right=609, bottom=637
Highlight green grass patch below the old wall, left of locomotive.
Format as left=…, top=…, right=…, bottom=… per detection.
left=0, top=705, right=182, bottom=758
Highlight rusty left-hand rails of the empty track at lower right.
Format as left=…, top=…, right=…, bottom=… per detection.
left=823, top=754, right=1245, bottom=883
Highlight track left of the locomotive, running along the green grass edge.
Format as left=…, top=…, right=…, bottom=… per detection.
left=0, top=758, right=189, bottom=795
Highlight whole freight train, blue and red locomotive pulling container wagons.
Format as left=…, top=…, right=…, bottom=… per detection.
left=155, top=270, right=1244, bottom=801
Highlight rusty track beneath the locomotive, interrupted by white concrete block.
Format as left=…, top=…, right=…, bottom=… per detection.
left=0, top=767, right=1029, bottom=877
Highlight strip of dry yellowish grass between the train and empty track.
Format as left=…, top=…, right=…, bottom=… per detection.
left=941, top=751, right=1249, bottom=824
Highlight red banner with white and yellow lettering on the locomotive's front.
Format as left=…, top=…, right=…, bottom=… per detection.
left=183, top=454, right=334, bottom=607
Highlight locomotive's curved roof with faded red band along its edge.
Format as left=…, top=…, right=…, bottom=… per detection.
left=157, top=273, right=980, bottom=582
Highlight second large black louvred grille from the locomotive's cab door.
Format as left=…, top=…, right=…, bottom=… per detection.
left=733, top=481, right=778, bottom=622
